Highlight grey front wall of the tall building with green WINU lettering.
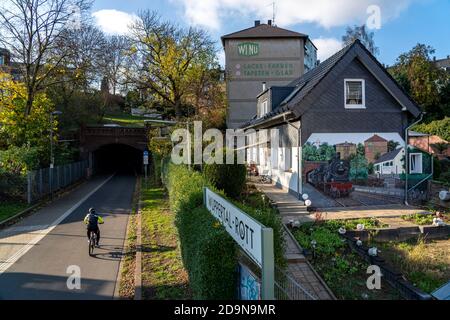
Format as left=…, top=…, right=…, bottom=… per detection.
left=225, top=38, right=304, bottom=129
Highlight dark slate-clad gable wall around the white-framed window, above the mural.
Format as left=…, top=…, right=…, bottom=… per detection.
left=296, top=58, right=407, bottom=142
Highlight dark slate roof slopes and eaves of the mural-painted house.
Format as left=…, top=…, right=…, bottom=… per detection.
left=243, top=40, right=420, bottom=128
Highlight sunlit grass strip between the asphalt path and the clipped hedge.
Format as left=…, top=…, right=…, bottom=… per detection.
left=141, top=182, right=191, bottom=300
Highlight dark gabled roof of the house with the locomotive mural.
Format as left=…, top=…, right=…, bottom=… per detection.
left=244, top=40, right=420, bottom=127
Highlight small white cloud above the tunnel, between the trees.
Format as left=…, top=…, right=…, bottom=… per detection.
left=92, top=9, right=138, bottom=35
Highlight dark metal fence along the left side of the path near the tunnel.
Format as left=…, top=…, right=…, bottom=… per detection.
left=26, top=160, right=89, bottom=204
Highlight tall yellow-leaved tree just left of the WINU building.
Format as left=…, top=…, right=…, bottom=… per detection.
left=127, top=11, right=216, bottom=119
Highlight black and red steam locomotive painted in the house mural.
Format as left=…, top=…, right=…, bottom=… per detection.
left=307, top=153, right=353, bottom=198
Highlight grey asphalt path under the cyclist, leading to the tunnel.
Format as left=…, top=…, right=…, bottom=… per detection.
left=0, top=175, right=136, bottom=300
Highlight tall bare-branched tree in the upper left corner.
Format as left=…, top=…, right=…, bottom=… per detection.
left=0, top=0, right=91, bottom=116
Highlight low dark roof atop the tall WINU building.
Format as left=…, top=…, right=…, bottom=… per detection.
left=222, top=24, right=308, bottom=43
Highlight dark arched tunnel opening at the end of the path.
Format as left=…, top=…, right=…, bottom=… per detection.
left=93, top=144, right=143, bottom=175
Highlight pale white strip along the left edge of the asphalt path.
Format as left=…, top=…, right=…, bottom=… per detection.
left=0, top=175, right=114, bottom=276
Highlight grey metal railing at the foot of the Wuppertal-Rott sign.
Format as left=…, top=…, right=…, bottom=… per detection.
left=275, top=267, right=317, bottom=300
